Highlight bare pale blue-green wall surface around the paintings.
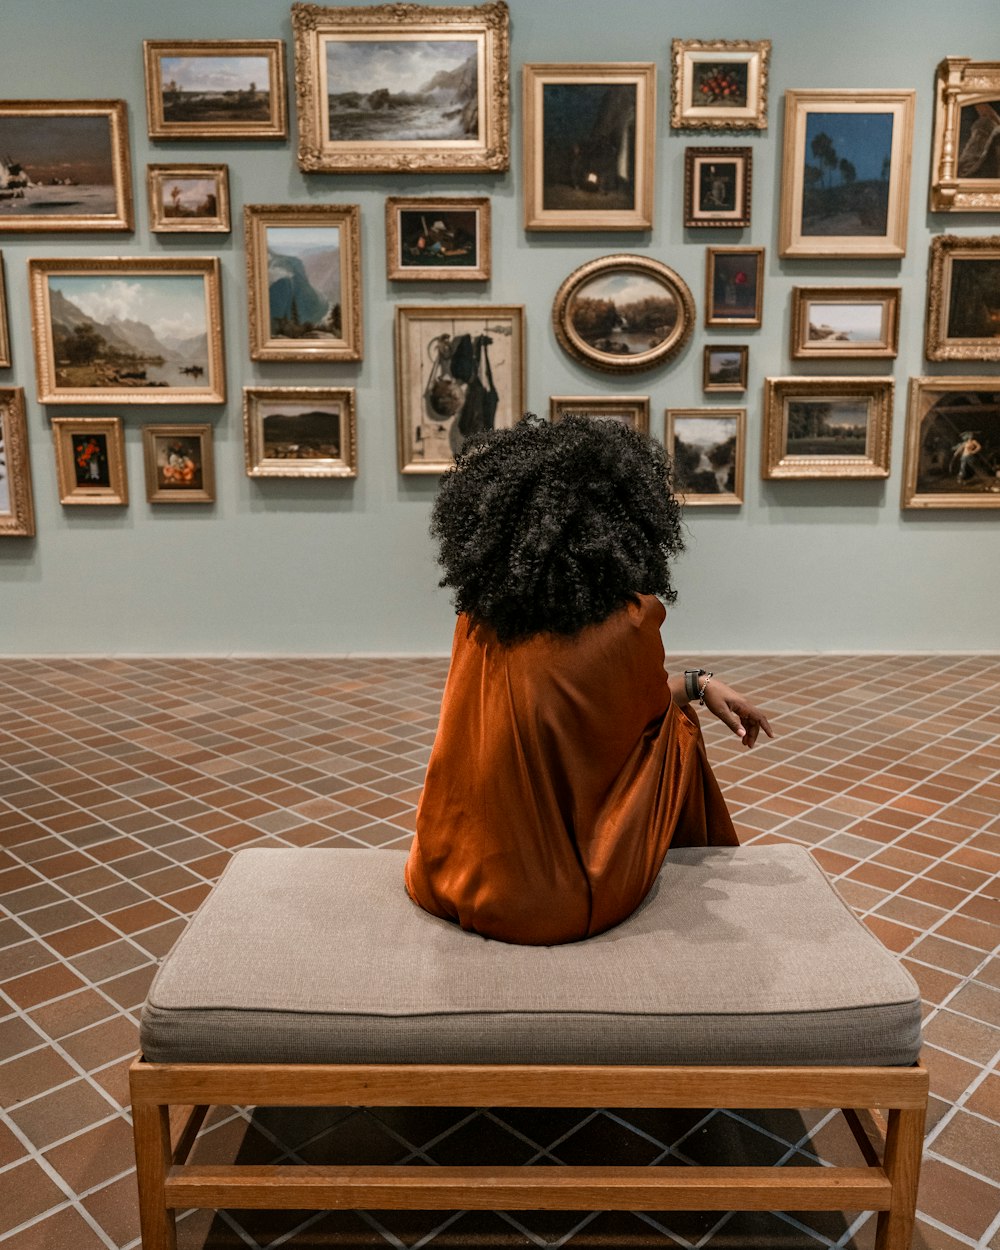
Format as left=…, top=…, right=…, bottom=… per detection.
left=0, top=0, right=1000, bottom=660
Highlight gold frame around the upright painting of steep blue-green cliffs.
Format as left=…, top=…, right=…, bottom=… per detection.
left=243, top=204, right=364, bottom=361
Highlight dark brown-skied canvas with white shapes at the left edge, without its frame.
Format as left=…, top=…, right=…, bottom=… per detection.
left=0, top=113, right=119, bottom=220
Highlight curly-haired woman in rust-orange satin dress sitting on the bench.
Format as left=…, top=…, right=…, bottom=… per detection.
left=406, top=416, right=774, bottom=945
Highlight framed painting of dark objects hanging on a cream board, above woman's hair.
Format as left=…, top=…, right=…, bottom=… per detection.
left=396, top=304, right=524, bottom=474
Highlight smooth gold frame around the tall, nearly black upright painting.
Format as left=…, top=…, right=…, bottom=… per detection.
left=521, top=61, right=656, bottom=230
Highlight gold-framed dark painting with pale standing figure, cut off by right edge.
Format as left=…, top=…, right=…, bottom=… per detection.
left=901, top=375, right=1000, bottom=508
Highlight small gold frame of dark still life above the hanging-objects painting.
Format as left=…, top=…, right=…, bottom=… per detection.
left=385, top=195, right=490, bottom=283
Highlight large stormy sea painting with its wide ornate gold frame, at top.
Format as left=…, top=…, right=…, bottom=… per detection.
left=291, top=0, right=510, bottom=174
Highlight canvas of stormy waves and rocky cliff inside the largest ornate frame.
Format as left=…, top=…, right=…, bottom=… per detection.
left=324, top=36, right=481, bottom=144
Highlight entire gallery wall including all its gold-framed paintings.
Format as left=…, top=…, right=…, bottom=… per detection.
left=0, top=0, right=1000, bottom=654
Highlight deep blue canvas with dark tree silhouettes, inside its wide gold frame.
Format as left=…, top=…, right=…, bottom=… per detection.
left=801, top=111, right=894, bottom=238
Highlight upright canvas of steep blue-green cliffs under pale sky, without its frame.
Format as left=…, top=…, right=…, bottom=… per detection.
left=265, top=225, right=344, bottom=341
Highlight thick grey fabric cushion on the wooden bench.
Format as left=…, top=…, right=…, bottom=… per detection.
left=141, top=845, right=920, bottom=1065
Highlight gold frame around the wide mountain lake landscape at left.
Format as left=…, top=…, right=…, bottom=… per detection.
left=28, top=256, right=226, bottom=404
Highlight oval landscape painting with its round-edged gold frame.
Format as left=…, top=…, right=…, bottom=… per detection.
left=553, top=255, right=695, bottom=373
